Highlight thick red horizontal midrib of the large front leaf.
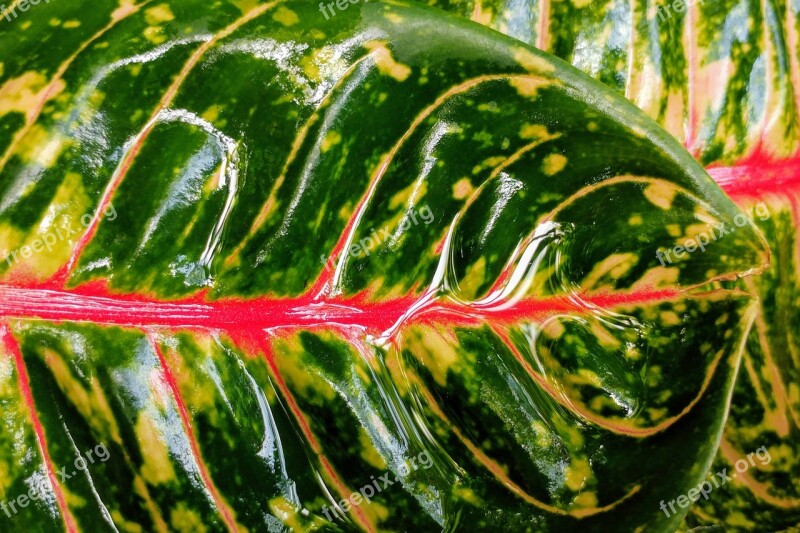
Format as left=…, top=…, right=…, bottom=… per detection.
left=0, top=285, right=686, bottom=333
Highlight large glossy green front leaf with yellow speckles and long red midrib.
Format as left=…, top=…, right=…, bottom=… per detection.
left=0, top=1, right=767, bottom=531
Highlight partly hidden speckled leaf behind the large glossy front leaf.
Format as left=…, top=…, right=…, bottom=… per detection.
left=438, top=0, right=800, bottom=531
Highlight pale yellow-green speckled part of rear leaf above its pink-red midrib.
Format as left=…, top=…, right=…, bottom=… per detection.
left=427, top=0, right=800, bottom=164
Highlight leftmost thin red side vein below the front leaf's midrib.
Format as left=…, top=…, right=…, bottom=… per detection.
left=0, top=325, right=78, bottom=533
